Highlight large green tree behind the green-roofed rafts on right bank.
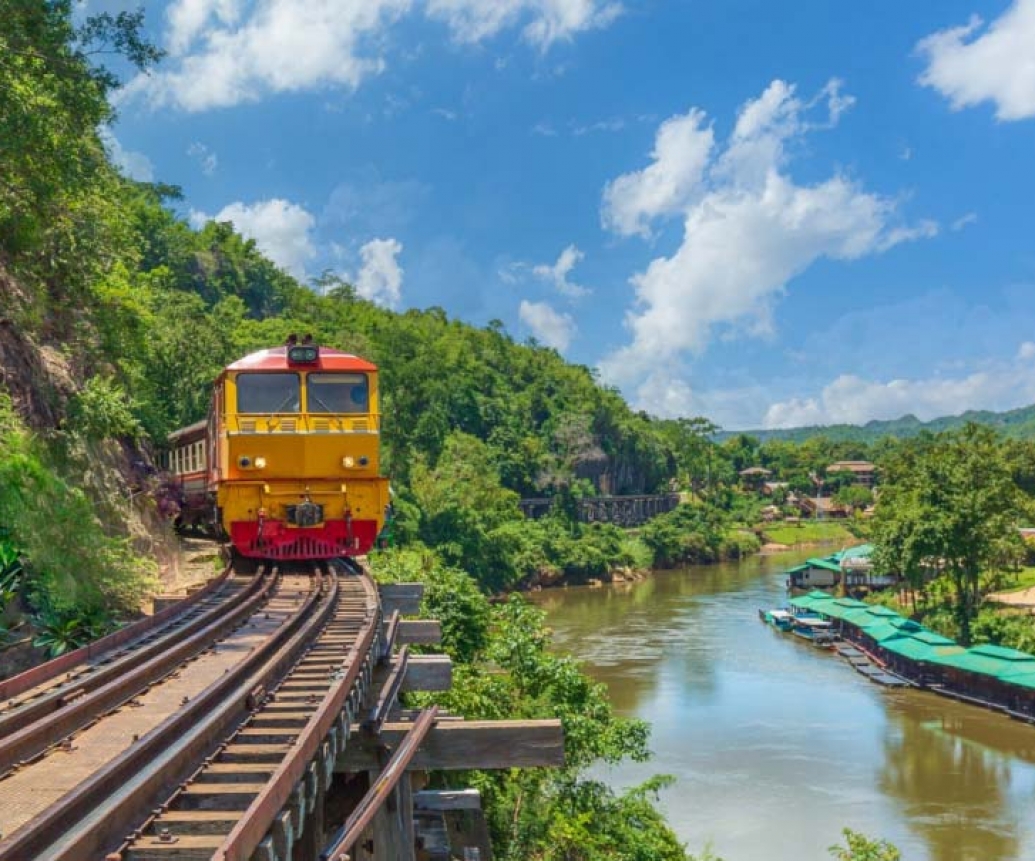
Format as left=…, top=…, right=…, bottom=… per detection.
left=874, top=423, right=1031, bottom=645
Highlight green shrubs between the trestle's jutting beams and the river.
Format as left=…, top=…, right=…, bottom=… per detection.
left=372, top=551, right=687, bottom=861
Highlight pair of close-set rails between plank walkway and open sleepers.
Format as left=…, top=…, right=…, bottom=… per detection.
left=0, top=571, right=327, bottom=861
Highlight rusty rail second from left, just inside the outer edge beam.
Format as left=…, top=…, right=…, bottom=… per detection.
left=0, top=571, right=254, bottom=740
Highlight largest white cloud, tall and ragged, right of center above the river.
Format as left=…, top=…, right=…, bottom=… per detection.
left=600, top=81, right=938, bottom=410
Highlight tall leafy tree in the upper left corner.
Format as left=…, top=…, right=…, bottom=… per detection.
left=0, top=0, right=161, bottom=289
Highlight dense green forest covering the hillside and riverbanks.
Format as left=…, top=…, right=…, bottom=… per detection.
left=0, top=8, right=1035, bottom=861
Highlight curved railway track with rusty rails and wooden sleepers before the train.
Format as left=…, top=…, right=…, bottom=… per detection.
left=0, top=562, right=381, bottom=861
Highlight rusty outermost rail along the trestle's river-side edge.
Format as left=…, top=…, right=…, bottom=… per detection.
left=213, top=574, right=381, bottom=861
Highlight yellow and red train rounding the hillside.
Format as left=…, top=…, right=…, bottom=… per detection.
left=162, top=335, right=391, bottom=564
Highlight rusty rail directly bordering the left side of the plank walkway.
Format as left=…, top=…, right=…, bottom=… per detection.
left=0, top=562, right=275, bottom=774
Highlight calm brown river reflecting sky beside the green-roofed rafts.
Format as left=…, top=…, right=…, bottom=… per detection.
left=534, top=554, right=1035, bottom=861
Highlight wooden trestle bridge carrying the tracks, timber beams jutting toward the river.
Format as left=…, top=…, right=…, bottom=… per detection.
left=0, top=564, right=563, bottom=861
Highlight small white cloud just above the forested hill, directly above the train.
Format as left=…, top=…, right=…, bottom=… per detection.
left=190, top=198, right=316, bottom=277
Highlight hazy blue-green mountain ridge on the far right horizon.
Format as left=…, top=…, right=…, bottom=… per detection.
left=716, top=404, right=1035, bottom=443
